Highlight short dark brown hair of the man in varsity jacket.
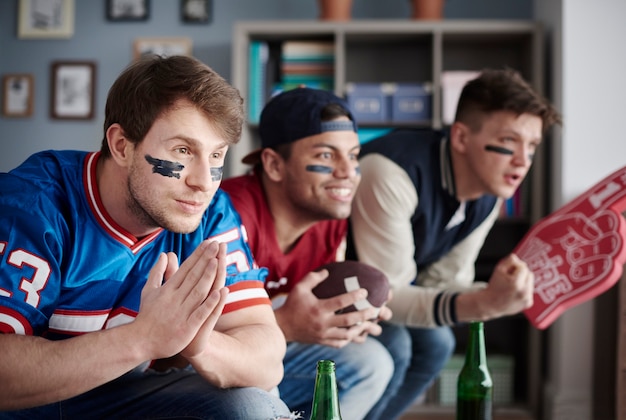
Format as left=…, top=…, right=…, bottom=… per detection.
left=455, top=69, right=561, bottom=131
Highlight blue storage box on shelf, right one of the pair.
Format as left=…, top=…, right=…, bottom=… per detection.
left=391, top=83, right=433, bottom=122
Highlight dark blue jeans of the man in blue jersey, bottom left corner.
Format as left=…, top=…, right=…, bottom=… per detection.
left=0, top=370, right=292, bottom=420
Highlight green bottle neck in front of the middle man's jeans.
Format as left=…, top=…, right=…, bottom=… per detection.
left=311, top=360, right=341, bottom=420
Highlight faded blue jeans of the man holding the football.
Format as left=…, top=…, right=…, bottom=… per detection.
left=278, top=337, right=394, bottom=420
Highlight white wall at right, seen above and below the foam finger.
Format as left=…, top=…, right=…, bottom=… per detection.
left=535, top=0, right=626, bottom=420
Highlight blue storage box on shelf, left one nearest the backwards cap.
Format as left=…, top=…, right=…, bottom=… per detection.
left=346, top=83, right=391, bottom=123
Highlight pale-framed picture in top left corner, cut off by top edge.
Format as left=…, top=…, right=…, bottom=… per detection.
left=17, top=0, right=74, bottom=39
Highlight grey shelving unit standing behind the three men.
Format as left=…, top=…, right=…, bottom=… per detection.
left=227, top=19, right=549, bottom=420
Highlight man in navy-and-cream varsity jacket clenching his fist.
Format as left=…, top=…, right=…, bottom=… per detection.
left=349, top=70, right=560, bottom=419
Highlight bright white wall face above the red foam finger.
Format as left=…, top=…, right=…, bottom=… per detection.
left=562, top=0, right=626, bottom=201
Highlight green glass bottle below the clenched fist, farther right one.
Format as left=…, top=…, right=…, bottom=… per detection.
left=456, top=322, right=493, bottom=420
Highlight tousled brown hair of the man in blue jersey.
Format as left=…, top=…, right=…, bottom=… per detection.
left=101, top=55, right=244, bottom=157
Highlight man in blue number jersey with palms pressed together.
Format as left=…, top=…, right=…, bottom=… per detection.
left=0, top=57, right=290, bottom=419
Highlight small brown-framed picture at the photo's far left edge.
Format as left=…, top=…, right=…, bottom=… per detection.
left=2, top=74, right=35, bottom=117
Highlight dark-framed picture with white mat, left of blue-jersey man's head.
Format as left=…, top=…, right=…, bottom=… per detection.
left=50, top=61, right=96, bottom=120
